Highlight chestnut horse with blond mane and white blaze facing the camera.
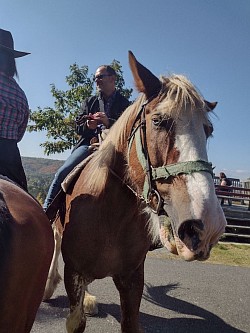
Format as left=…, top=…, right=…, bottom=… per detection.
left=46, top=52, right=226, bottom=333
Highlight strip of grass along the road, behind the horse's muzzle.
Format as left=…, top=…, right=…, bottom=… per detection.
left=148, top=243, right=250, bottom=267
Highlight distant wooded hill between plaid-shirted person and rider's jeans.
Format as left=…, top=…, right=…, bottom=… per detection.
left=22, top=157, right=64, bottom=203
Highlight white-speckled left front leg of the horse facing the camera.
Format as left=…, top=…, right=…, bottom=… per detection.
left=64, top=264, right=86, bottom=333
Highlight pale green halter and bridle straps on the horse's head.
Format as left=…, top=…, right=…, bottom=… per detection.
left=128, top=98, right=213, bottom=214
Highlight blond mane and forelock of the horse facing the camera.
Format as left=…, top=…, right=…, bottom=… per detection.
left=81, top=75, right=209, bottom=197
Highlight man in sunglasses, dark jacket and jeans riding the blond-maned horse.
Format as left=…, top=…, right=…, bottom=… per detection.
left=44, top=65, right=130, bottom=211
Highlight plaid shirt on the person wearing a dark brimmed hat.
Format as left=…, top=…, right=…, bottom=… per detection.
left=0, top=72, right=29, bottom=142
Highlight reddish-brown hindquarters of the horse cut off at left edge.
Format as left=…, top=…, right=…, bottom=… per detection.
left=0, top=179, right=54, bottom=333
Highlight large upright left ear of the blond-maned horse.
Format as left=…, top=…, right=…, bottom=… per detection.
left=128, top=51, right=161, bottom=99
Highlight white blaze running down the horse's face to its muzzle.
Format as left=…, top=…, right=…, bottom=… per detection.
left=168, top=109, right=226, bottom=260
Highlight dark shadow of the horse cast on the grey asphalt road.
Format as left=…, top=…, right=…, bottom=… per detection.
left=34, top=284, right=245, bottom=333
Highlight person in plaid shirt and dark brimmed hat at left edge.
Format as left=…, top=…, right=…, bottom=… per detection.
left=0, top=29, right=29, bottom=191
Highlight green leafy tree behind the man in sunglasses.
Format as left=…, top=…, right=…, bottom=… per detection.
left=27, top=60, right=133, bottom=155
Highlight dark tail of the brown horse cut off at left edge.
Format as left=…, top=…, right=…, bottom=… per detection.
left=0, top=192, right=13, bottom=271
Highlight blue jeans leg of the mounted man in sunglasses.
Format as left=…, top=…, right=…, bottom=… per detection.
left=43, top=146, right=90, bottom=210
